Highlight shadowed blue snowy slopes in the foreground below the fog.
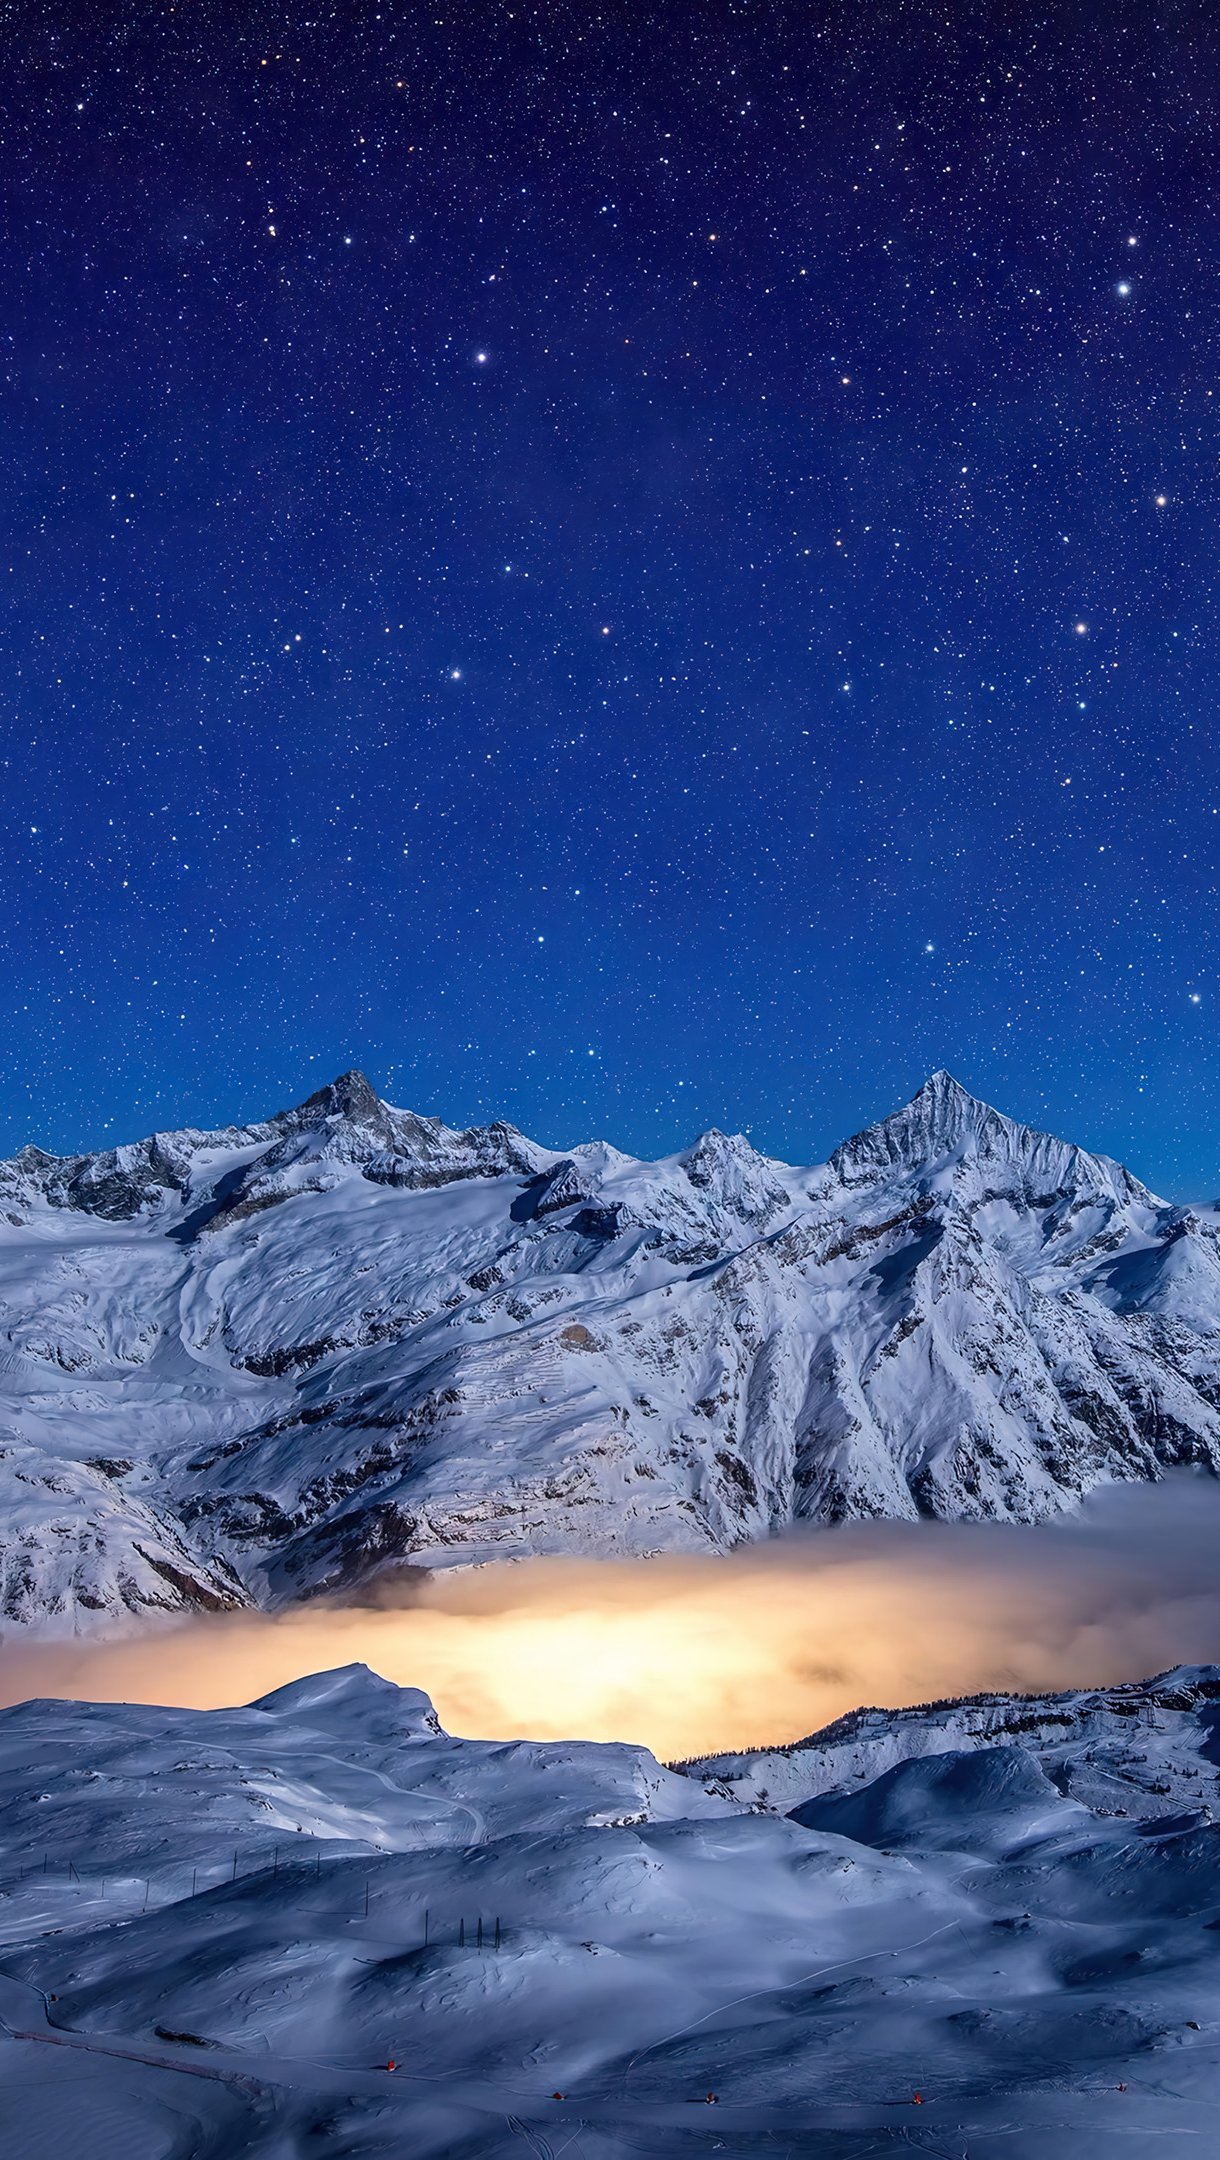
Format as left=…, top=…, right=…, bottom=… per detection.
left=0, top=1668, right=1220, bottom=2160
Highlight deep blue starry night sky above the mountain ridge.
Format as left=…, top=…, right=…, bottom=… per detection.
left=0, top=0, right=1220, bottom=1197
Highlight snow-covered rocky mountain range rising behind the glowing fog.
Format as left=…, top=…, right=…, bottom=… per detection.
left=0, top=1074, right=1220, bottom=1629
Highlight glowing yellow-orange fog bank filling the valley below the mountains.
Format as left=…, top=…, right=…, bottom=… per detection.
left=0, top=1475, right=1220, bottom=1758
